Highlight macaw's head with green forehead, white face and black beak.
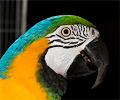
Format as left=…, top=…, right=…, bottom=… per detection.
left=41, top=15, right=108, bottom=88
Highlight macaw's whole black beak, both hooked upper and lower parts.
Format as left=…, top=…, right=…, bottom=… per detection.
left=67, top=38, right=109, bottom=88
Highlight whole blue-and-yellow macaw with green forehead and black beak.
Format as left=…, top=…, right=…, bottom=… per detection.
left=0, top=15, right=108, bottom=100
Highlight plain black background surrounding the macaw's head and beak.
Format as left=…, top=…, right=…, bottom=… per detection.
left=27, top=1, right=119, bottom=99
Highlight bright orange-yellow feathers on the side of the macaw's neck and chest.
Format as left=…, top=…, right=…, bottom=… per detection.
left=0, top=37, right=49, bottom=100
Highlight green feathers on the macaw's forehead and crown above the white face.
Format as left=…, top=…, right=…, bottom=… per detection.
left=47, top=15, right=96, bottom=34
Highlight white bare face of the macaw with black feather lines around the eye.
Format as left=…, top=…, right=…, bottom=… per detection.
left=45, top=24, right=99, bottom=78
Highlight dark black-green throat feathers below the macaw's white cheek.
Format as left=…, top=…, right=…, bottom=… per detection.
left=37, top=52, right=67, bottom=100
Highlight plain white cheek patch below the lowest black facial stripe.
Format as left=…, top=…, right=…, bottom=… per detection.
left=45, top=47, right=80, bottom=77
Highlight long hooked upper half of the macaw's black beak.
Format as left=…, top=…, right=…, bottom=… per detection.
left=85, top=38, right=109, bottom=88
